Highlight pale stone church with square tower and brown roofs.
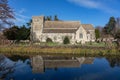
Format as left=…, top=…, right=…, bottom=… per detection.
left=31, top=16, right=95, bottom=44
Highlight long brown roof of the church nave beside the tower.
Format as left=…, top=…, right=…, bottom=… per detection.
left=43, top=21, right=80, bottom=33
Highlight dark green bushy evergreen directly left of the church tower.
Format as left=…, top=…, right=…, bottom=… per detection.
left=3, top=25, right=30, bottom=41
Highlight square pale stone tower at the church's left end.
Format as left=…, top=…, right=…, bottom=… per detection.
left=31, top=16, right=44, bottom=42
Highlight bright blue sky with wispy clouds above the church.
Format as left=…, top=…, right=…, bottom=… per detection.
left=9, top=0, right=120, bottom=26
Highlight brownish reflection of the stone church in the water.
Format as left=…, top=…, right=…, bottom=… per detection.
left=31, top=55, right=94, bottom=73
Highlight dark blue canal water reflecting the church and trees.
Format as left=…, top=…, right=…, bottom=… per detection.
left=0, top=55, right=120, bottom=80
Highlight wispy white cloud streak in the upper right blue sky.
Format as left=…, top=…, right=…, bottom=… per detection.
left=68, top=0, right=117, bottom=13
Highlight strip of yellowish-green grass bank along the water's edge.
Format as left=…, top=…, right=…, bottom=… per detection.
left=0, top=46, right=120, bottom=56
